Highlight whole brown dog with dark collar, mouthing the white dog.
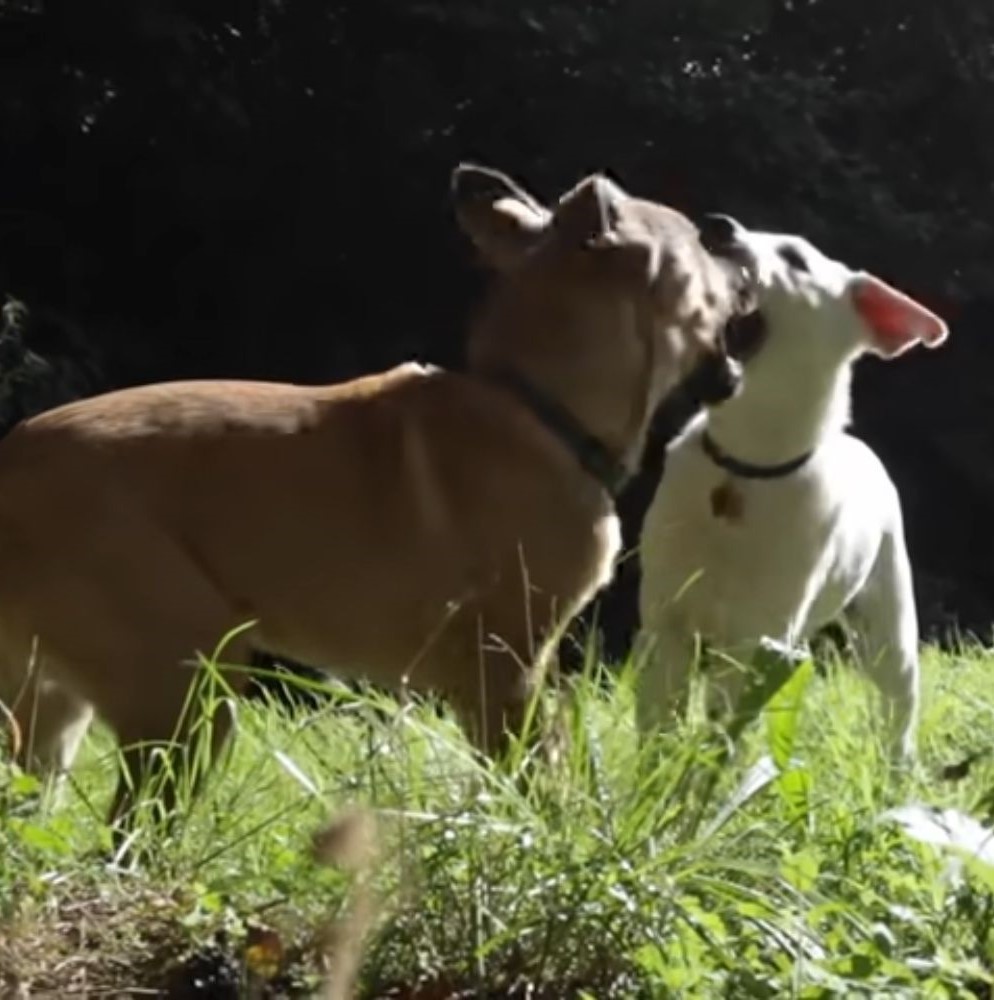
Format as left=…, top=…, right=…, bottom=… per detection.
left=0, top=166, right=747, bottom=818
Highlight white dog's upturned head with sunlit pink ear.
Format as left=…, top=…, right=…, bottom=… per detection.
left=700, top=215, right=949, bottom=378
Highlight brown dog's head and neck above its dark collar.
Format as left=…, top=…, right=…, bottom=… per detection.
left=452, top=164, right=754, bottom=472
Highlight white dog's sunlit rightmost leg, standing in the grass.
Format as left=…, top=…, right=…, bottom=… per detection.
left=847, top=530, right=920, bottom=763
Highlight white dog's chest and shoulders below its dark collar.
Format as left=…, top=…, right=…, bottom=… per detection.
left=642, top=434, right=892, bottom=641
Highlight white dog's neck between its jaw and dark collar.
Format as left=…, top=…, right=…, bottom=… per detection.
left=707, top=363, right=852, bottom=466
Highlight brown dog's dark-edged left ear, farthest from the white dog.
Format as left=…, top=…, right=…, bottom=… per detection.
left=451, top=163, right=551, bottom=270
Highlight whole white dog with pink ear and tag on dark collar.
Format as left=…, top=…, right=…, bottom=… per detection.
left=639, top=216, right=948, bottom=760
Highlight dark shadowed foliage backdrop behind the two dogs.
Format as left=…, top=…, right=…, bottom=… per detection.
left=0, top=0, right=994, bottom=668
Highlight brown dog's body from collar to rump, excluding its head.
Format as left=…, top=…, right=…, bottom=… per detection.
left=0, top=365, right=613, bottom=748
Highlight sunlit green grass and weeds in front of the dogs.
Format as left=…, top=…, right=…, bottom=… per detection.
left=0, top=652, right=994, bottom=1000
